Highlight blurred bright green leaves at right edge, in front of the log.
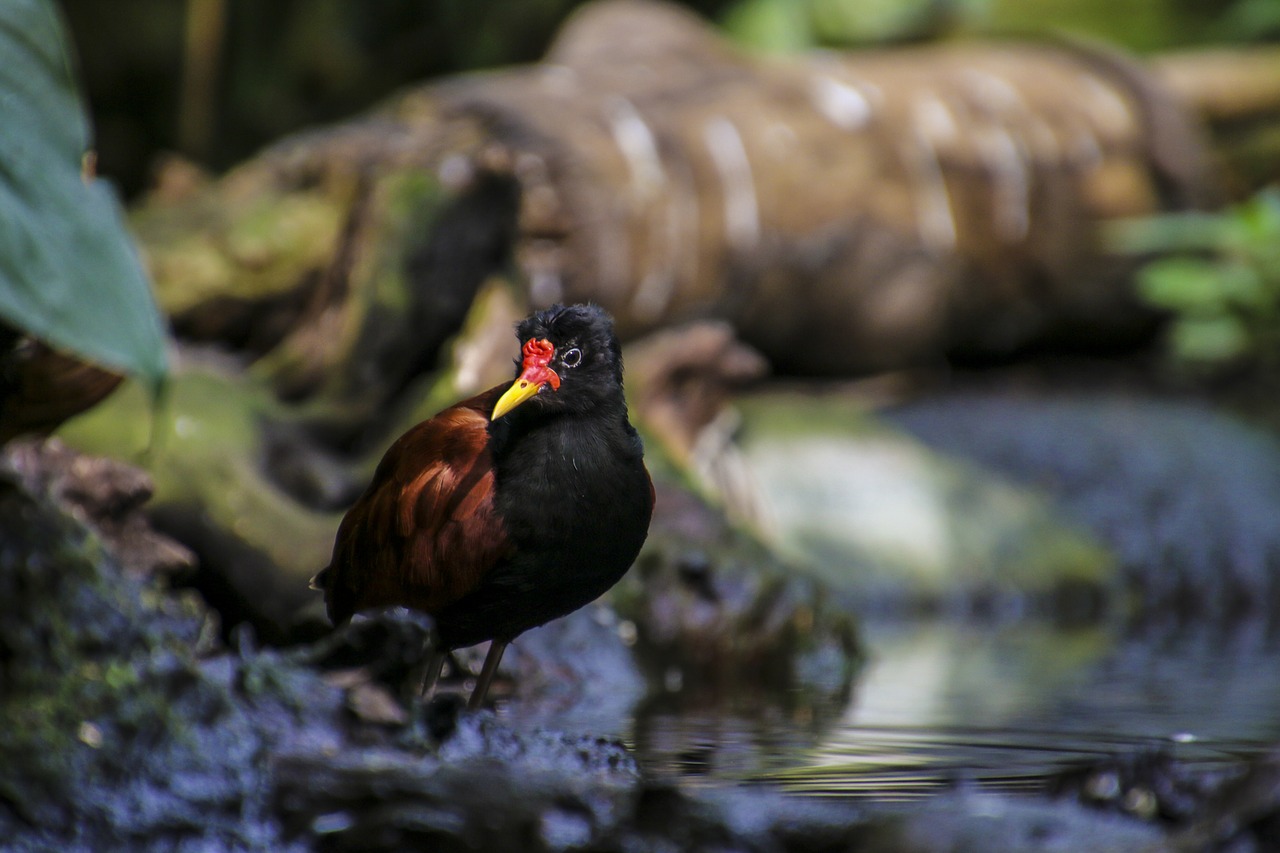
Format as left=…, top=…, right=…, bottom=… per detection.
left=1116, top=187, right=1280, bottom=368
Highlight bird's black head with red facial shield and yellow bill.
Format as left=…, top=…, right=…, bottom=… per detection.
left=493, top=305, right=622, bottom=420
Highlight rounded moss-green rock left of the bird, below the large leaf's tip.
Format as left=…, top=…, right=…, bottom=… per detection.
left=60, top=352, right=343, bottom=642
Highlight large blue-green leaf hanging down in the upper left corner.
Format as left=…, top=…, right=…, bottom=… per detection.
left=0, top=0, right=165, bottom=384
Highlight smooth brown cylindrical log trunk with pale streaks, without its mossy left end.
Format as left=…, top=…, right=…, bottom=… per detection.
left=424, top=1, right=1210, bottom=373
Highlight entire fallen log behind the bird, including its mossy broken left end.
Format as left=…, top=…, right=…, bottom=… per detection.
left=137, top=0, right=1280, bottom=397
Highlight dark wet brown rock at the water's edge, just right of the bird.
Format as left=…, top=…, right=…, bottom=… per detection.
left=609, top=473, right=860, bottom=699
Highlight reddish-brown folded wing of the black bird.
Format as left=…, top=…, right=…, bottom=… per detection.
left=317, top=387, right=511, bottom=624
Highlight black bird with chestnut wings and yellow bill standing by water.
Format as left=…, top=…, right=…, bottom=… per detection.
left=312, top=305, right=654, bottom=708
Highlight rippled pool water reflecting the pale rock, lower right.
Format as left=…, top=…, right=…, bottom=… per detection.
left=614, top=622, right=1280, bottom=802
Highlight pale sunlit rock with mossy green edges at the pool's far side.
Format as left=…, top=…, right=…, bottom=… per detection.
left=721, top=392, right=1124, bottom=616
